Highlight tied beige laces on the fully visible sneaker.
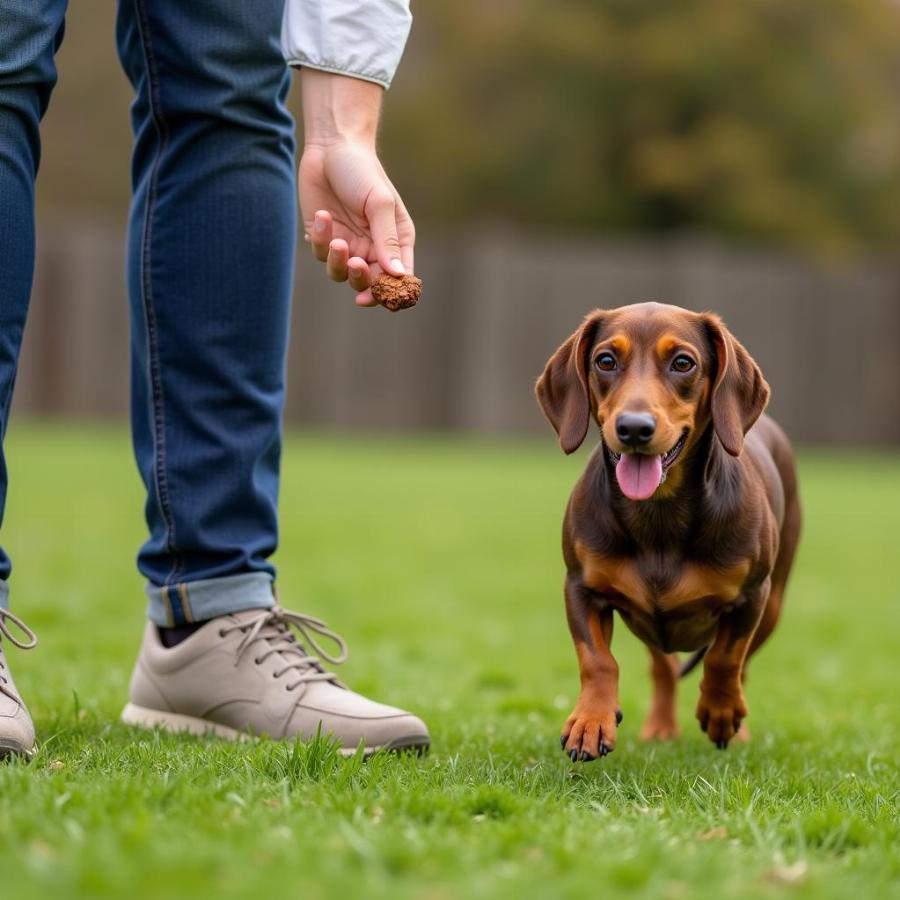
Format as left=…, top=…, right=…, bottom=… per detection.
left=219, top=606, right=347, bottom=691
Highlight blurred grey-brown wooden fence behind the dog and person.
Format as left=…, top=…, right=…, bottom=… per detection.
left=15, top=222, right=900, bottom=444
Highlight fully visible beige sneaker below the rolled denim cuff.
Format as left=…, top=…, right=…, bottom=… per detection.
left=122, top=606, right=430, bottom=756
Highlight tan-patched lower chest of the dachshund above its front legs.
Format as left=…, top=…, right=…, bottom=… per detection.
left=576, top=545, right=750, bottom=652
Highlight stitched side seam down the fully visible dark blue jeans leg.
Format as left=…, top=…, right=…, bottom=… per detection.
left=134, top=0, right=184, bottom=585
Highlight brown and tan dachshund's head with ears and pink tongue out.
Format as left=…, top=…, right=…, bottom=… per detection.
left=537, top=303, right=769, bottom=500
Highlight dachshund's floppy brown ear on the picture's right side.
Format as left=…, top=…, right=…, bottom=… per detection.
left=703, top=313, right=769, bottom=456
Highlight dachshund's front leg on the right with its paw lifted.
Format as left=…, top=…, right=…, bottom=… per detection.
left=697, top=579, right=769, bottom=750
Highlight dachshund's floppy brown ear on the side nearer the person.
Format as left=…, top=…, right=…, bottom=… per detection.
left=535, top=310, right=603, bottom=453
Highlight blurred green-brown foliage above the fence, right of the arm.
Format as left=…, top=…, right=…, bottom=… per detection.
left=383, top=0, right=900, bottom=254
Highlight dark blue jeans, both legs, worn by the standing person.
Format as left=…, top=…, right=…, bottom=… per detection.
left=0, top=0, right=296, bottom=625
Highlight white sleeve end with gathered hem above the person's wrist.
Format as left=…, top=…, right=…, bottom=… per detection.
left=281, top=0, right=412, bottom=88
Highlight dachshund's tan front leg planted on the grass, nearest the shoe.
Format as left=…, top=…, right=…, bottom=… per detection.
left=560, top=575, right=622, bottom=762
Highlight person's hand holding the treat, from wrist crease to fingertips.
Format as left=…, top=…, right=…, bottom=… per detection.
left=299, top=141, right=415, bottom=306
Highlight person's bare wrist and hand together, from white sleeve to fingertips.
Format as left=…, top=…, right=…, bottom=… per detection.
left=298, top=68, right=415, bottom=306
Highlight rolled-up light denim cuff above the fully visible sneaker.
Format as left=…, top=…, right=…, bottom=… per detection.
left=147, top=572, right=275, bottom=628
